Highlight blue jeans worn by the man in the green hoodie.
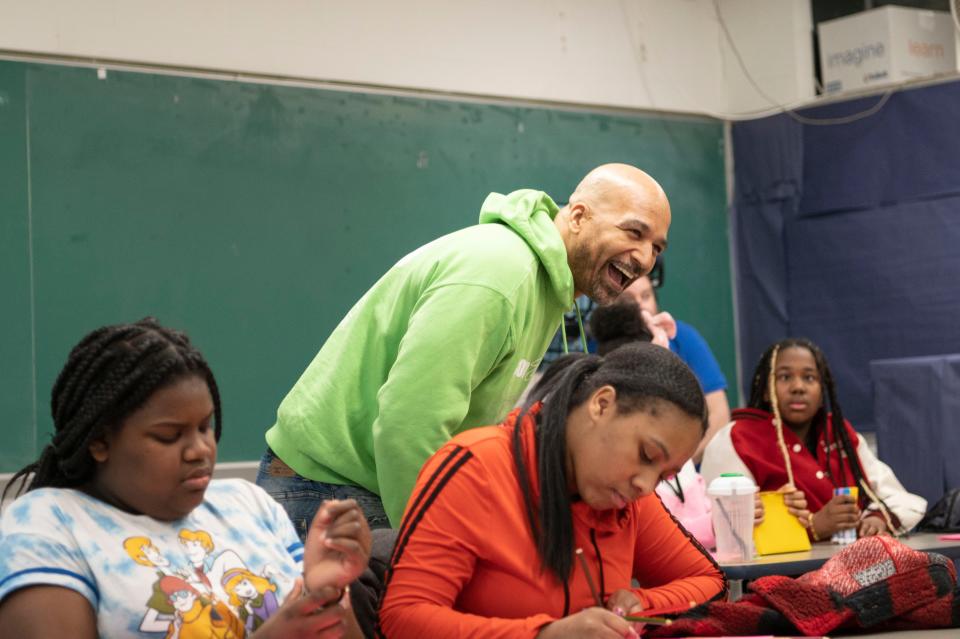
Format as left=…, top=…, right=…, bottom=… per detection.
left=257, top=448, right=390, bottom=542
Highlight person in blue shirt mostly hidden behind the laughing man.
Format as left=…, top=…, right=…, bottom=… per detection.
left=621, top=276, right=730, bottom=464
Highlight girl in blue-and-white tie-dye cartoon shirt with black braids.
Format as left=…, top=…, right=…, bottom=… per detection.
left=0, top=318, right=371, bottom=639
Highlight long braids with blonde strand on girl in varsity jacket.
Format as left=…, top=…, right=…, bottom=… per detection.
left=748, top=337, right=900, bottom=532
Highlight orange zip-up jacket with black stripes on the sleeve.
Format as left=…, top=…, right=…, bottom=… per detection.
left=380, top=412, right=725, bottom=639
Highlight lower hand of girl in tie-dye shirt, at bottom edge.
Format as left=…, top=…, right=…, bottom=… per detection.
left=254, top=580, right=356, bottom=639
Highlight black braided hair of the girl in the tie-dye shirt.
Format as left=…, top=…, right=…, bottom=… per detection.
left=3, top=317, right=221, bottom=498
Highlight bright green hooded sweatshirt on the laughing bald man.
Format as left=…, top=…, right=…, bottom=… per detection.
left=266, top=190, right=573, bottom=527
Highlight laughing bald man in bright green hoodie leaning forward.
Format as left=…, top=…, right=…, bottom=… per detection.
left=257, top=164, right=670, bottom=538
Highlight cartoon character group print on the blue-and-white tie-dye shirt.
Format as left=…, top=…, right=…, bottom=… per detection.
left=123, top=528, right=279, bottom=639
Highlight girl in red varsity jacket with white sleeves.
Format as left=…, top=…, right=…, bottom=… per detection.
left=700, top=338, right=927, bottom=540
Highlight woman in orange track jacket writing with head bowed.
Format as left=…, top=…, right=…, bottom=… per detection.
left=379, top=344, right=726, bottom=639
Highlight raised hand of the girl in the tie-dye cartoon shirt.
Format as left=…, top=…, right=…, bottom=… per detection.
left=303, top=499, right=372, bottom=593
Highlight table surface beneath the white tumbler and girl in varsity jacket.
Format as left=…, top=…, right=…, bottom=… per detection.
left=719, top=533, right=960, bottom=604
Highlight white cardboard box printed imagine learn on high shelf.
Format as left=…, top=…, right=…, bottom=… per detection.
left=817, top=6, right=957, bottom=93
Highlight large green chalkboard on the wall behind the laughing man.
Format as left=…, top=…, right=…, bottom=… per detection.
left=0, top=61, right=735, bottom=472
